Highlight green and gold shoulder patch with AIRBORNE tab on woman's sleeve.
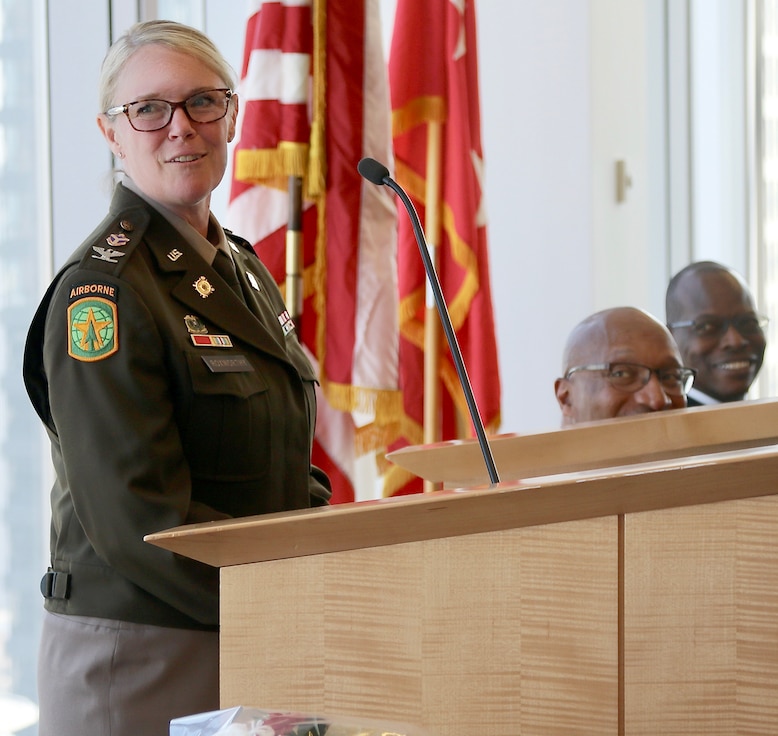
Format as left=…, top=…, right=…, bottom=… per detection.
left=68, top=283, right=119, bottom=363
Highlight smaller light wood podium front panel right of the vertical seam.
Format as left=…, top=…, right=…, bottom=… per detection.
left=623, top=496, right=778, bottom=736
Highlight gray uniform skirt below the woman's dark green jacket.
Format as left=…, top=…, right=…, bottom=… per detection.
left=38, top=611, right=219, bottom=736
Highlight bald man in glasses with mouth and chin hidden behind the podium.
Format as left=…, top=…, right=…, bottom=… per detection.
left=554, top=307, right=694, bottom=425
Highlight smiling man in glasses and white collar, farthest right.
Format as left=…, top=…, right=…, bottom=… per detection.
left=665, top=261, right=767, bottom=406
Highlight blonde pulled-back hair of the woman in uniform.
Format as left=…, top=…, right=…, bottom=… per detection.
left=98, top=20, right=236, bottom=111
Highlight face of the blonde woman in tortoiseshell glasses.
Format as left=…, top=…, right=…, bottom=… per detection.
left=98, top=44, right=233, bottom=232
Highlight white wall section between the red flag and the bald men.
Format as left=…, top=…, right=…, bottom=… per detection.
left=477, top=0, right=595, bottom=432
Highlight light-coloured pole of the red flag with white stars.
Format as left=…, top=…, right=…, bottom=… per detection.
left=424, top=121, right=441, bottom=493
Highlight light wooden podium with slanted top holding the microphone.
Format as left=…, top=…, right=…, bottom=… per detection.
left=148, top=401, right=778, bottom=736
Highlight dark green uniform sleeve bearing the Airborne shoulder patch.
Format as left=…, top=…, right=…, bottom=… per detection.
left=43, top=274, right=225, bottom=623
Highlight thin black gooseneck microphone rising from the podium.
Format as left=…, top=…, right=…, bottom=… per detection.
left=357, top=158, right=500, bottom=484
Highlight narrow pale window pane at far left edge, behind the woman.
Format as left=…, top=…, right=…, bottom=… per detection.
left=0, top=0, right=51, bottom=734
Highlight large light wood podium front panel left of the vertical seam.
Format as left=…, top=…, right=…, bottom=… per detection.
left=221, top=518, right=618, bottom=736
